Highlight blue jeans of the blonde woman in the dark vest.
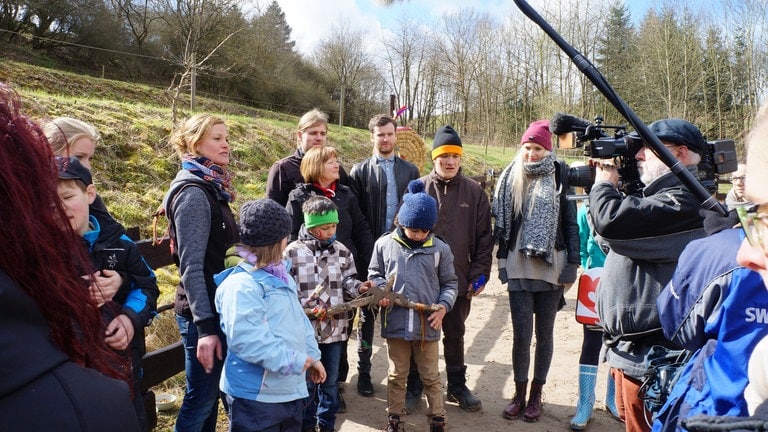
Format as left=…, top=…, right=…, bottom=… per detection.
left=174, top=315, right=224, bottom=432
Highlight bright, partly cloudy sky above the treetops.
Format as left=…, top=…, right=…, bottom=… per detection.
left=272, top=0, right=659, bottom=54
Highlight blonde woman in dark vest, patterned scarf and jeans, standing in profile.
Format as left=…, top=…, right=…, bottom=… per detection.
left=163, top=114, right=238, bottom=432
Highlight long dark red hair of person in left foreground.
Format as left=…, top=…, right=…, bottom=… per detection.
left=0, top=83, right=127, bottom=380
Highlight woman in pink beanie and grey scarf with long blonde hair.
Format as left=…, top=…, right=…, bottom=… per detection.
left=492, top=120, right=580, bottom=422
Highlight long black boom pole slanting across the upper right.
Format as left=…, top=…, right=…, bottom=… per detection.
left=515, top=0, right=728, bottom=216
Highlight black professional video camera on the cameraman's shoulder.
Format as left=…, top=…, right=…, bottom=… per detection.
left=550, top=113, right=738, bottom=195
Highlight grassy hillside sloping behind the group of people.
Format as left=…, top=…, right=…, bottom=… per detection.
left=0, top=60, right=511, bottom=240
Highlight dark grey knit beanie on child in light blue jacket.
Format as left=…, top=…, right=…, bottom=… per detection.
left=240, top=198, right=293, bottom=246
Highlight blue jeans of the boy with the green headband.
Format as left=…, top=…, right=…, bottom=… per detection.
left=304, top=342, right=346, bottom=429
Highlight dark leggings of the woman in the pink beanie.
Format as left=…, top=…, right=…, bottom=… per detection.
left=509, top=287, right=563, bottom=384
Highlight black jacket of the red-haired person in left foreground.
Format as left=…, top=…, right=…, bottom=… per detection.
left=0, top=271, right=139, bottom=432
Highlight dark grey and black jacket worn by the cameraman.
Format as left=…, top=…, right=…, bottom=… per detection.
left=589, top=167, right=705, bottom=379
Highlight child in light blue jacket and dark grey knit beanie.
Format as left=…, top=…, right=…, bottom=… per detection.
left=214, top=199, right=326, bottom=432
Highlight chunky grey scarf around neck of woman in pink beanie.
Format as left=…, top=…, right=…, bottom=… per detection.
left=493, top=153, right=560, bottom=264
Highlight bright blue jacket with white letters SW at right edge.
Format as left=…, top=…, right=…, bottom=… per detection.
left=653, top=229, right=768, bottom=431
